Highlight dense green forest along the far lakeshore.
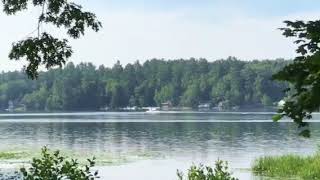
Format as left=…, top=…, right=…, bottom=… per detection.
left=0, top=57, right=290, bottom=111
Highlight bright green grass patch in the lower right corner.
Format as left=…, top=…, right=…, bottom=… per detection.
left=252, top=152, right=320, bottom=180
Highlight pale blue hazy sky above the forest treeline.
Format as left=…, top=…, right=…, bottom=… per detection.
left=0, top=0, right=320, bottom=71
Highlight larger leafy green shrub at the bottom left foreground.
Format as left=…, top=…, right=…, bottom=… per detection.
left=20, top=147, right=99, bottom=180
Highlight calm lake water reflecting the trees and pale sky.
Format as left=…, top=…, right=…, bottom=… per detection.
left=0, top=112, right=320, bottom=180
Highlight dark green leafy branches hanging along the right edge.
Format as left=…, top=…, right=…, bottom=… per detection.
left=273, top=20, right=320, bottom=136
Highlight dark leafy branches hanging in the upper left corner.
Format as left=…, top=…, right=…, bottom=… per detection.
left=2, top=0, right=102, bottom=79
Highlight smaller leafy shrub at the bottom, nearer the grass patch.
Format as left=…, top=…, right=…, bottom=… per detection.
left=177, top=160, right=237, bottom=180
